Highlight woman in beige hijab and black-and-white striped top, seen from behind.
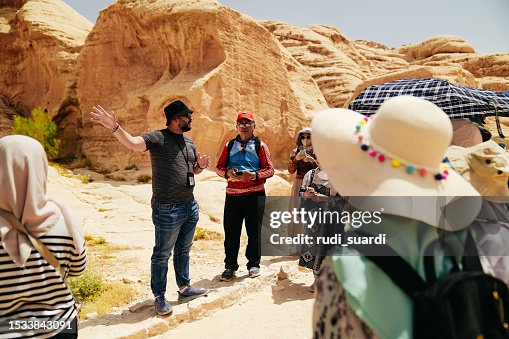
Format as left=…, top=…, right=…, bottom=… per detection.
left=0, top=135, right=86, bottom=338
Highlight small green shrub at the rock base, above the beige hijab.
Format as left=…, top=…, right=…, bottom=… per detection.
left=12, top=108, right=61, bottom=160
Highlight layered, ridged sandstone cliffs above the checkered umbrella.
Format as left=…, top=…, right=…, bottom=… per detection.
left=262, top=26, right=509, bottom=107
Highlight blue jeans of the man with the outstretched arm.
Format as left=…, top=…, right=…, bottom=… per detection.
left=150, top=200, right=199, bottom=296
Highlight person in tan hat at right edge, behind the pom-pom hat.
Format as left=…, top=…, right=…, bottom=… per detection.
left=447, top=140, right=509, bottom=284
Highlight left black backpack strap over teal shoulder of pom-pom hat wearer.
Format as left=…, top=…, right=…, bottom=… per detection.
left=348, top=230, right=427, bottom=298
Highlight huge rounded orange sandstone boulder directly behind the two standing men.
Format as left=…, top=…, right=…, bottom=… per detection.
left=77, top=0, right=327, bottom=169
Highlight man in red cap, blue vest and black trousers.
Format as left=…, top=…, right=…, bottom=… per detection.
left=216, top=112, right=274, bottom=281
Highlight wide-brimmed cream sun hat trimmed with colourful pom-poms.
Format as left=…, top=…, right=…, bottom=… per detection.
left=312, top=96, right=481, bottom=230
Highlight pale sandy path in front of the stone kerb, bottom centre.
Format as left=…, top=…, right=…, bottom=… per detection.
left=155, top=274, right=314, bottom=339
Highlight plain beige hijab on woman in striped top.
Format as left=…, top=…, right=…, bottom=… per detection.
left=0, top=135, right=84, bottom=267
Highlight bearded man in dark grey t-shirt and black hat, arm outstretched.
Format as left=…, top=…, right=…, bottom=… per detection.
left=90, top=100, right=210, bottom=315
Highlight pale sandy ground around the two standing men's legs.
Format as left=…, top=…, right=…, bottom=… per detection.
left=48, top=168, right=313, bottom=338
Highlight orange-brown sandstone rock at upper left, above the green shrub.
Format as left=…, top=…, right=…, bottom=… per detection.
left=0, top=0, right=92, bottom=149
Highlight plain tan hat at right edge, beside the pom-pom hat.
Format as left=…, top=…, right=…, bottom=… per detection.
left=447, top=140, right=509, bottom=203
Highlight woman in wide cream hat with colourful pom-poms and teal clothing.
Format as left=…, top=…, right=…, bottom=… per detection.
left=312, top=96, right=480, bottom=338
